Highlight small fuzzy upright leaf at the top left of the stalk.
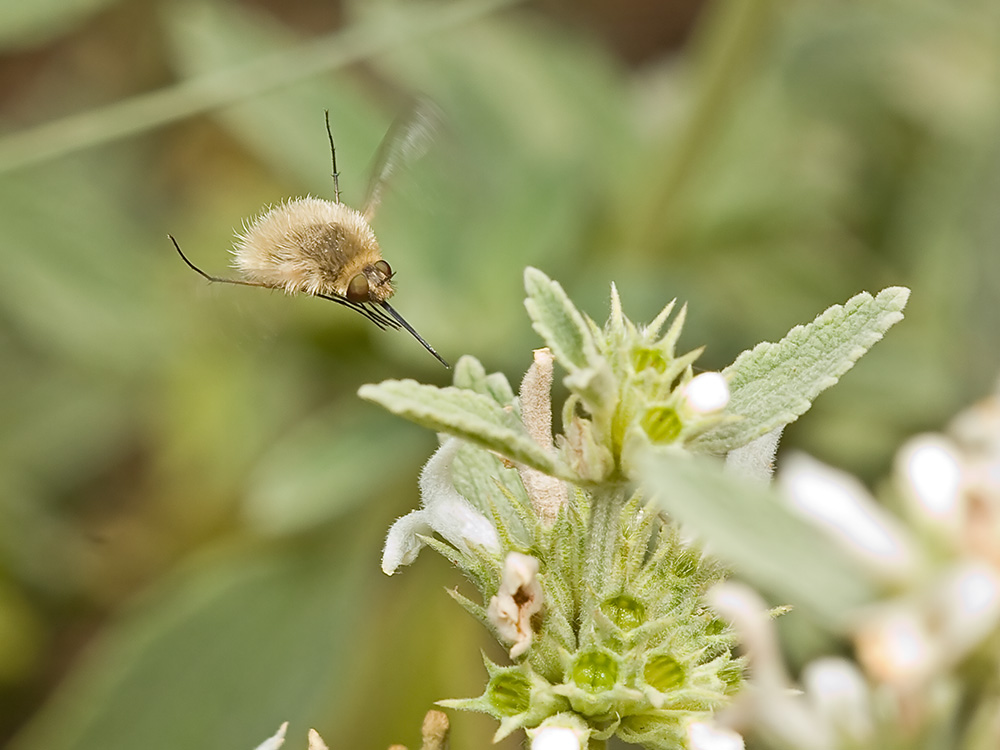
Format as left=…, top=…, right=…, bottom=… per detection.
left=524, top=266, right=597, bottom=372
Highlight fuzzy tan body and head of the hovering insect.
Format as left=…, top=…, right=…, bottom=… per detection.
left=233, top=198, right=393, bottom=302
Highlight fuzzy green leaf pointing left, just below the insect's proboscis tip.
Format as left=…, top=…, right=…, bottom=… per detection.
left=358, top=380, right=571, bottom=478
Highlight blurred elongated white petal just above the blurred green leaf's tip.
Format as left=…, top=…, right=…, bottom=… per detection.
left=779, top=453, right=916, bottom=580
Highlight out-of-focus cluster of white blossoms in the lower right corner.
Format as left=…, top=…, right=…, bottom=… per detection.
left=709, top=388, right=1000, bottom=750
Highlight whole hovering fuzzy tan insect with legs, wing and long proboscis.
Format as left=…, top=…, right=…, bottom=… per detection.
left=167, top=103, right=448, bottom=367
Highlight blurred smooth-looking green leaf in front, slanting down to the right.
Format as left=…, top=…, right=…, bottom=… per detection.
left=641, top=452, right=877, bottom=627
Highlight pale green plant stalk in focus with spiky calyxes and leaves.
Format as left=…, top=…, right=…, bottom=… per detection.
left=360, top=268, right=908, bottom=750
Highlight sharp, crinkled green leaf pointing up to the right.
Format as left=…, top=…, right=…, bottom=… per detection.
left=691, top=287, right=910, bottom=454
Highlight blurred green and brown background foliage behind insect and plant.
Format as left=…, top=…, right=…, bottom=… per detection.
left=0, top=0, right=1000, bottom=750
